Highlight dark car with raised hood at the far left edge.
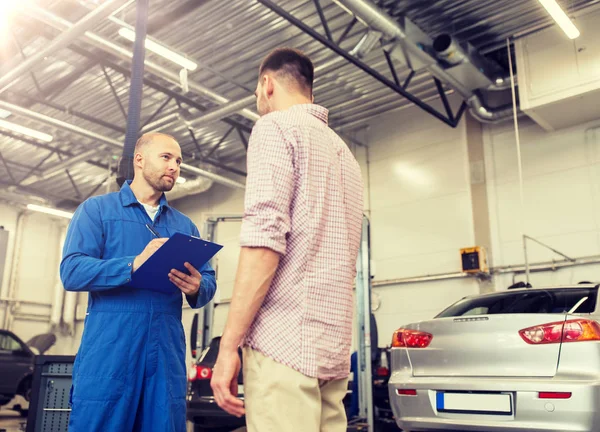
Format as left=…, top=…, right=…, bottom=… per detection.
left=0, top=330, right=56, bottom=416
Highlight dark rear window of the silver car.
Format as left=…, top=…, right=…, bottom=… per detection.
left=437, top=288, right=598, bottom=318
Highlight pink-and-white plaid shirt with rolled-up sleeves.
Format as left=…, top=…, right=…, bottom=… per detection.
left=241, top=104, right=363, bottom=379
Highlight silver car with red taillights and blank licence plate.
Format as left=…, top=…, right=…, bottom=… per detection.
left=389, top=284, right=600, bottom=432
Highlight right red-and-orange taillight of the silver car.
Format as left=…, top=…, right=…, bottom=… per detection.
left=519, top=319, right=600, bottom=345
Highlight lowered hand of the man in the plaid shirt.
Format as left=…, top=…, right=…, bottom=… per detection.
left=210, top=350, right=246, bottom=417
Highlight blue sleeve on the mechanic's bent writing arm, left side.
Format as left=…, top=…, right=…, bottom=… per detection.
left=60, top=199, right=135, bottom=291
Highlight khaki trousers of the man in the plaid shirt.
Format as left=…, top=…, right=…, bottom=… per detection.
left=244, top=347, right=348, bottom=432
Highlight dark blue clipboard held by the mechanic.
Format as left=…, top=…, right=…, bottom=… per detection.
left=127, top=233, right=223, bottom=294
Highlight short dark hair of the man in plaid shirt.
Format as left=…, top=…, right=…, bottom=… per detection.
left=259, top=48, right=315, bottom=96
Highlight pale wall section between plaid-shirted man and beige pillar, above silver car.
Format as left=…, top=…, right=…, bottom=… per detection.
left=357, top=102, right=479, bottom=346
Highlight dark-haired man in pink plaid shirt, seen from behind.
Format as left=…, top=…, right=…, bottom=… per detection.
left=211, top=48, right=363, bottom=432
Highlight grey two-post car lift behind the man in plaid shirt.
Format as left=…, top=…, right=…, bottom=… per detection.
left=195, top=215, right=375, bottom=432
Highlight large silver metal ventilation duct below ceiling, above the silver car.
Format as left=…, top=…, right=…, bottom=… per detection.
left=335, top=0, right=512, bottom=122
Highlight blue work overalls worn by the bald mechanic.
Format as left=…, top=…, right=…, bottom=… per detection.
left=60, top=182, right=216, bottom=432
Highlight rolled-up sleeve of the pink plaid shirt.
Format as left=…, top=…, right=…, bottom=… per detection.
left=240, top=118, right=295, bottom=255
